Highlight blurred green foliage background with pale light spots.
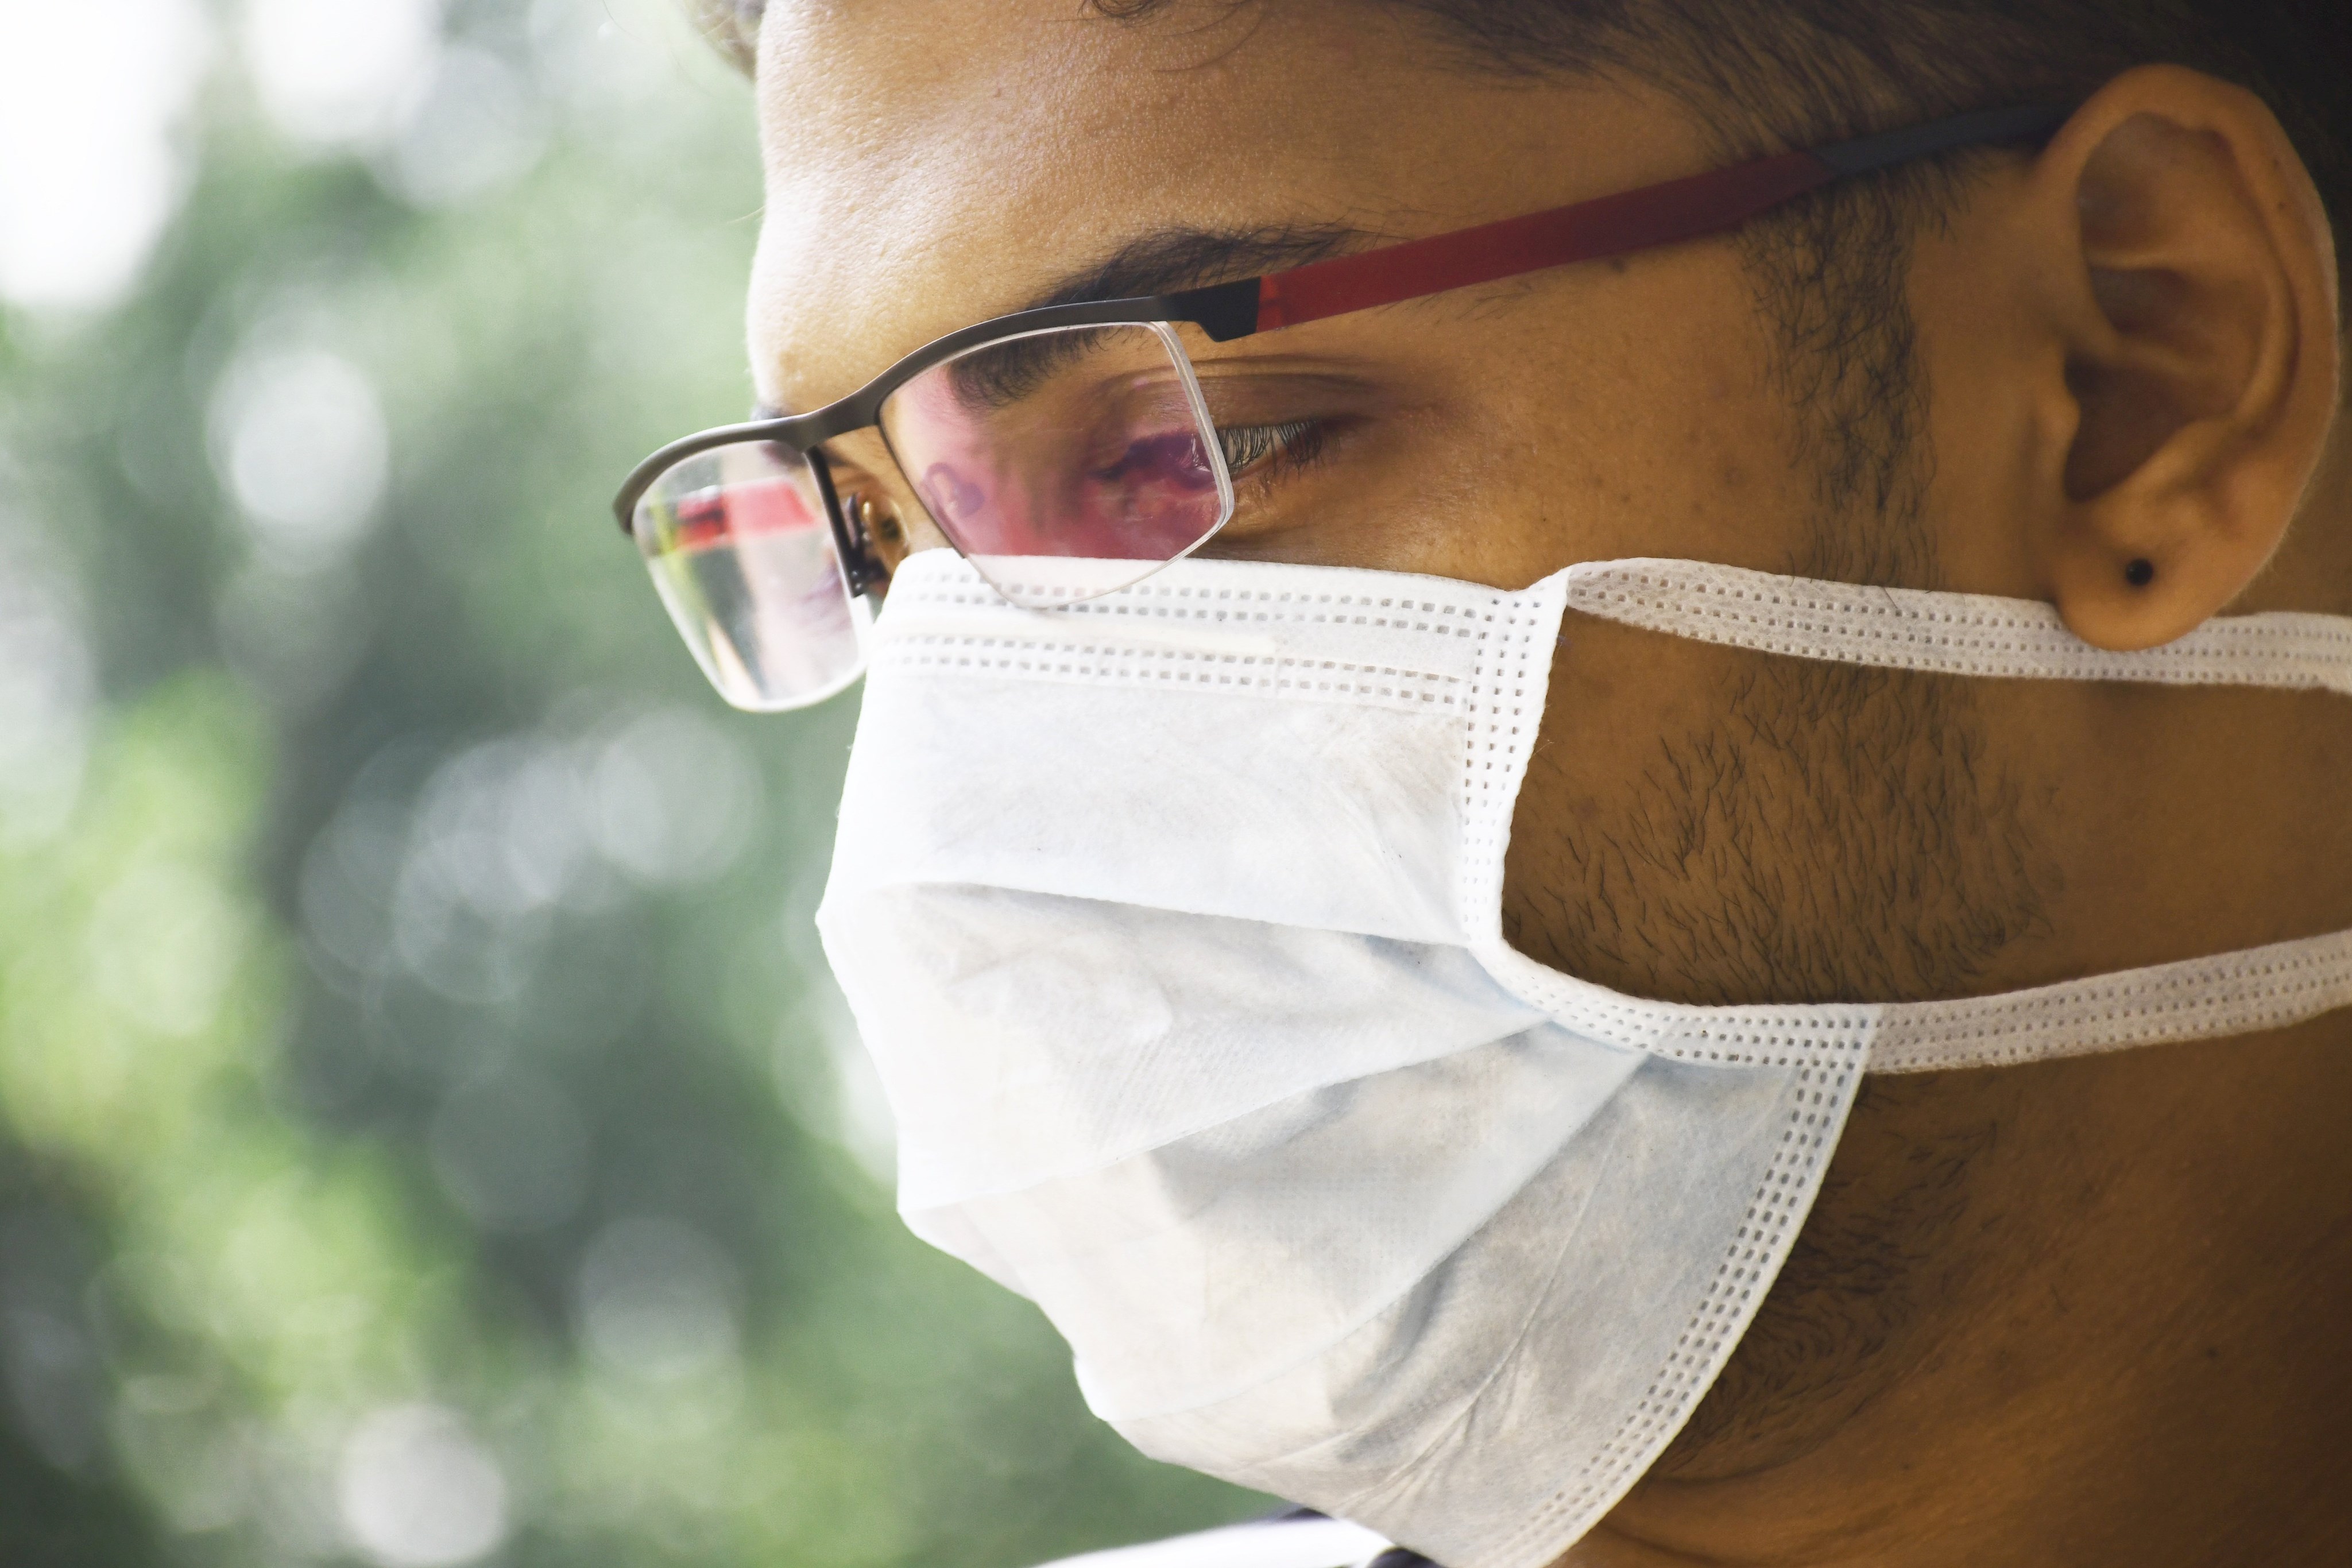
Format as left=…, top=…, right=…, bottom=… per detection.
left=0, top=0, right=1258, bottom=1568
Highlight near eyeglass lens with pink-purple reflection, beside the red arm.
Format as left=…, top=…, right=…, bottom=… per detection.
left=882, top=327, right=1232, bottom=604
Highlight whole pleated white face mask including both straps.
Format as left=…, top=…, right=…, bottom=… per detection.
left=818, top=550, right=2352, bottom=1568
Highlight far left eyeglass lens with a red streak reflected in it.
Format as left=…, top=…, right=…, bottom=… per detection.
left=635, top=442, right=868, bottom=713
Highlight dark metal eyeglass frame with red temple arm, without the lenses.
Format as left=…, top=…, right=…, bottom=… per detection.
left=612, top=103, right=2072, bottom=595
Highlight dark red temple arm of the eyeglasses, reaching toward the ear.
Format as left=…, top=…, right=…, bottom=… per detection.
left=1176, top=103, right=2067, bottom=341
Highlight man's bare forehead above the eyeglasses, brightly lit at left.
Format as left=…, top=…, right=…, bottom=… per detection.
left=748, top=0, right=1696, bottom=409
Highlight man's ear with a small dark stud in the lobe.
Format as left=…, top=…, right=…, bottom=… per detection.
left=2030, top=66, right=2341, bottom=649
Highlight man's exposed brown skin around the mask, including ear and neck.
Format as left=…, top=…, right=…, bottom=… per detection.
left=751, top=0, right=2352, bottom=1568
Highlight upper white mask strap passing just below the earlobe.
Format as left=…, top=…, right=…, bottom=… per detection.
left=1566, top=559, right=2352, bottom=696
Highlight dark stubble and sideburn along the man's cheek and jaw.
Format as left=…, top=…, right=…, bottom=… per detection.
left=1510, top=177, right=2058, bottom=1481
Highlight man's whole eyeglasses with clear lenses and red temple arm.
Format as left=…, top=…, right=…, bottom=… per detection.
left=614, top=106, right=2067, bottom=713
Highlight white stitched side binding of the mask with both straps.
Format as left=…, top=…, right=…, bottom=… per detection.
left=1463, top=559, right=2352, bottom=1072
